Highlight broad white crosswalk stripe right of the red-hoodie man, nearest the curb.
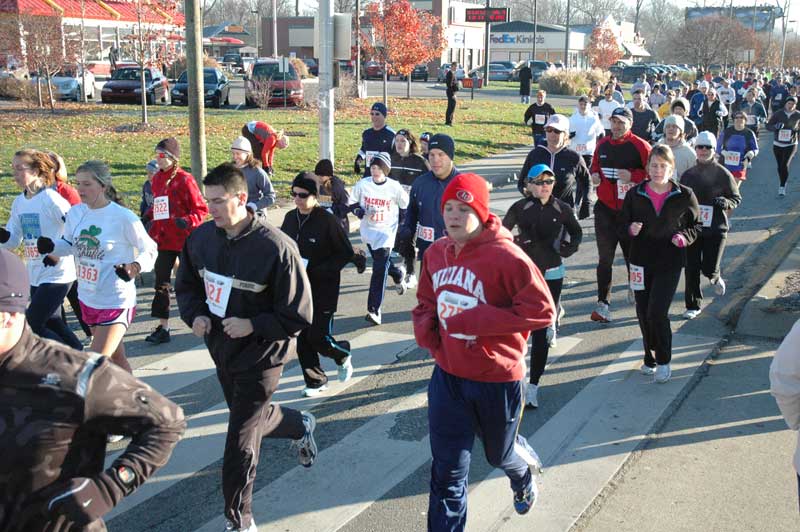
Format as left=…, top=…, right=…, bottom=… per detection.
left=468, top=334, right=716, bottom=532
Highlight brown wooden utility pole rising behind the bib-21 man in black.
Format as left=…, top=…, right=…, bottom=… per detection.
left=183, top=0, right=206, bottom=185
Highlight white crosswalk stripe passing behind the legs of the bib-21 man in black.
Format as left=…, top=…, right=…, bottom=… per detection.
left=106, top=331, right=416, bottom=528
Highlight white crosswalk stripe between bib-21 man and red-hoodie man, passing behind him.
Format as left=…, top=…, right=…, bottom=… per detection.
left=191, top=337, right=581, bottom=532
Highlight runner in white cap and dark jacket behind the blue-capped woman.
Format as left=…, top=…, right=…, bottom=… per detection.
left=517, top=114, right=591, bottom=219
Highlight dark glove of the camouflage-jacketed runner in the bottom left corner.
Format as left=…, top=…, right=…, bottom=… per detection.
left=46, top=473, right=114, bottom=529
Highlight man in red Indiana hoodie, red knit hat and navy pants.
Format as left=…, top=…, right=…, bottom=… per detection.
left=413, top=174, right=555, bottom=532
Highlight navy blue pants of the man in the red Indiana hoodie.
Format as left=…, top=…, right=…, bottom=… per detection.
left=428, top=365, right=532, bottom=532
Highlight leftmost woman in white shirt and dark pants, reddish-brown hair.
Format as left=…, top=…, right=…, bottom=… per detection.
left=0, top=149, right=83, bottom=351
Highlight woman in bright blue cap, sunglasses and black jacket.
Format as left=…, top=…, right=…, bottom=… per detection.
left=503, top=164, right=583, bottom=408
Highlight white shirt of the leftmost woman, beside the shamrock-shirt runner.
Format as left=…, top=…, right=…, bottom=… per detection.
left=3, top=188, right=75, bottom=286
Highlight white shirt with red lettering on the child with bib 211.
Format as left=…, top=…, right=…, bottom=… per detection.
left=352, top=176, right=408, bottom=249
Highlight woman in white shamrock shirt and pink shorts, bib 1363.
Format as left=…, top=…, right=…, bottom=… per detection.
left=44, top=161, right=157, bottom=373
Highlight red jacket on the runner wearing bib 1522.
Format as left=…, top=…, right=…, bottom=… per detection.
left=144, top=168, right=208, bottom=251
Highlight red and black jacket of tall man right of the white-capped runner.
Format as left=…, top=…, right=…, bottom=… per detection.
left=592, top=131, right=651, bottom=211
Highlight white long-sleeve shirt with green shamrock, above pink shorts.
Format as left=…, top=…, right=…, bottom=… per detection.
left=54, top=203, right=158, bottom=309
